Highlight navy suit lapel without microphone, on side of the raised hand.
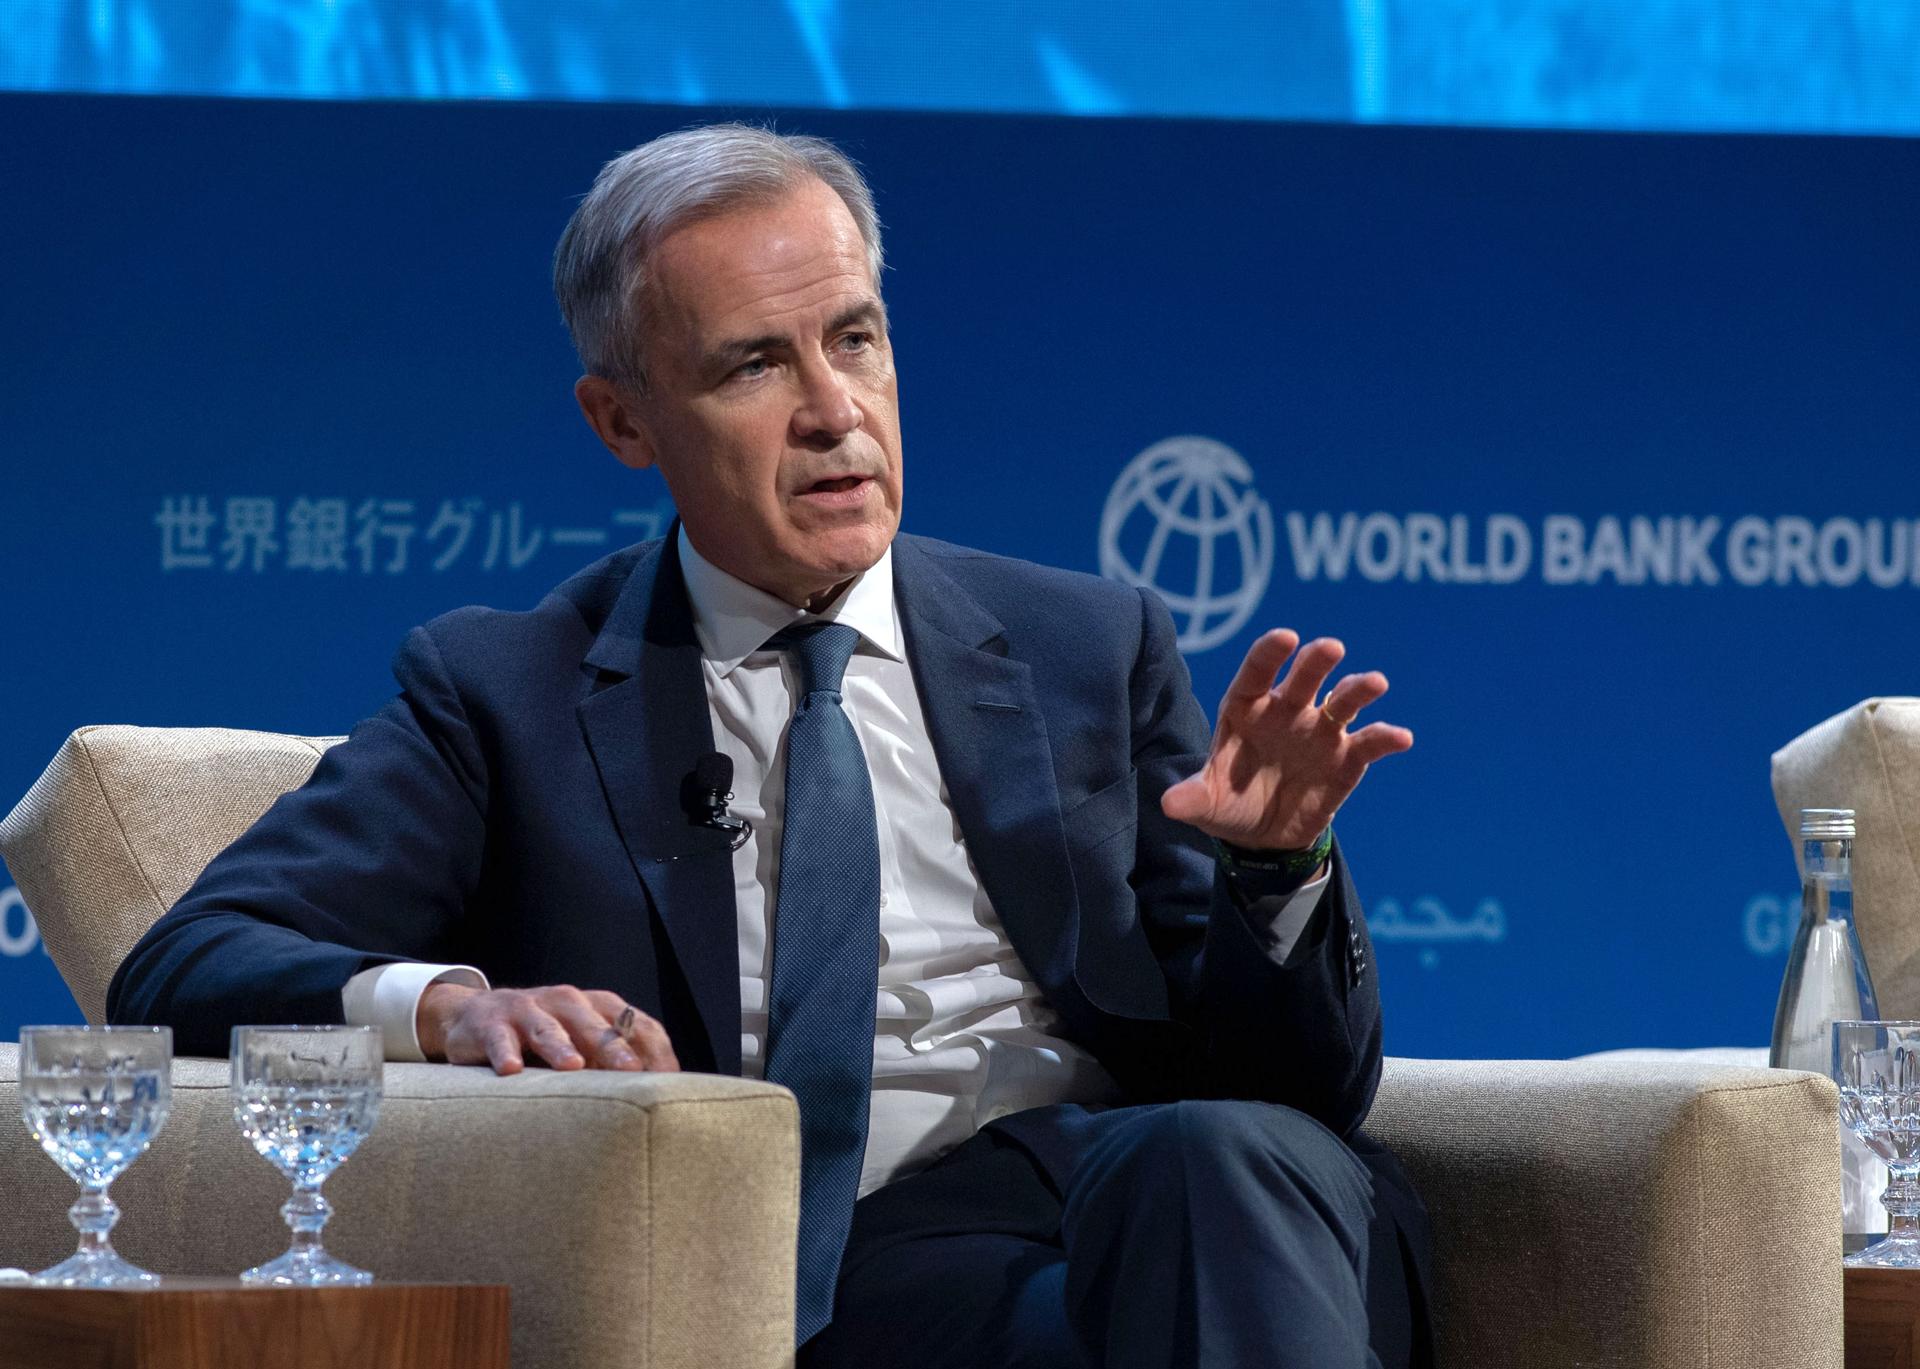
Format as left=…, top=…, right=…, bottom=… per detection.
left=893, top=538, right=1079, bottom=1000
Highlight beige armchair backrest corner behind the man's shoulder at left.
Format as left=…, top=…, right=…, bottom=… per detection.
left=0, top=726, right=340, bottom=1023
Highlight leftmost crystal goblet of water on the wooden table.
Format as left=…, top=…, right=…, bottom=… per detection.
left=19, top=1027, right=173, bottom=1288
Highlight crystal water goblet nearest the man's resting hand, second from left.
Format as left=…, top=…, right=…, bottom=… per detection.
left=232, top=1027, right=384, bottom=1288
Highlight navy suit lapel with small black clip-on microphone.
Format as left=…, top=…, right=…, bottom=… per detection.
left=580, top=524, right=739, bottom=1073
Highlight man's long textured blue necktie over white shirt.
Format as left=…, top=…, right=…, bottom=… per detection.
left=766, top=622, right=879, bottom=1344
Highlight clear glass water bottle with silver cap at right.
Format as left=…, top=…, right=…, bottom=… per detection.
left=1766, top=808, right=1880, bottom=1075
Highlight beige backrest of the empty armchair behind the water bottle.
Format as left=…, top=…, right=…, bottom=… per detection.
left=1766, top=699, right=1920, bottom=1018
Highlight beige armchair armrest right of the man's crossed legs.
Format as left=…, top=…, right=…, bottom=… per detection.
left=1367, top=1060, right=1843, bottom=1369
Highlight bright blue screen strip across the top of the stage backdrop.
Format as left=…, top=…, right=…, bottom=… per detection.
left=0, top=0, right=1920, bottom=132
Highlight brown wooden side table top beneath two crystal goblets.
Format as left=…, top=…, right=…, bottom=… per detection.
left=0, top=1279, right=509, bottom=1369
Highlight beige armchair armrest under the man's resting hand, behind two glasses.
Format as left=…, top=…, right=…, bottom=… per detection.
left=0, top=1046, right=799, bottom=1369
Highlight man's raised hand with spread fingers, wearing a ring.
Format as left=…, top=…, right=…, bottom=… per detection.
left=1160, top=628, right=1413, bottom=851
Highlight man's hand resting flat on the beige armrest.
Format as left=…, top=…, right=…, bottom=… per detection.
left=415, top=983, right=680, bottom=1075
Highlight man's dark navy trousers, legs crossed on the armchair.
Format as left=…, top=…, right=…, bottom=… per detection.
left=799, top=1102, right=1417, bottom=1369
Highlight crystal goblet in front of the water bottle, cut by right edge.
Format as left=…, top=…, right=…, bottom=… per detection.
left=1832, top=1021, right=1920, bottom=1269
